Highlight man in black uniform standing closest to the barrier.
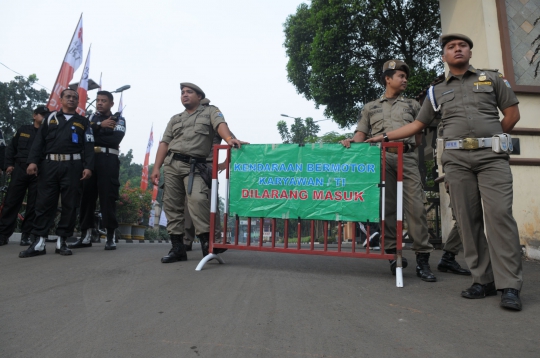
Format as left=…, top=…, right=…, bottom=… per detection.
left=69, top=91, right=126, bottom=250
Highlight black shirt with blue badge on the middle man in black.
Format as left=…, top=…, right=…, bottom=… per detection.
left=27, top=111, right=94, bottom=170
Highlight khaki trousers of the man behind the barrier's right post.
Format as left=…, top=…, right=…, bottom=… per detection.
left=384, top=152, right=433, bottom=253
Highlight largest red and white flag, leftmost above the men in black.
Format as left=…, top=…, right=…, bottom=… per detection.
left=47, top=14, right=83, bottom=111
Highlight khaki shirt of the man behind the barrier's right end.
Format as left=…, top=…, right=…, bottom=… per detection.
left=355, top=95, right=420, bottom=145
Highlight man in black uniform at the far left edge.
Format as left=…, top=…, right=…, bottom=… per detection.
left=0, top=106, right=49, bottom=246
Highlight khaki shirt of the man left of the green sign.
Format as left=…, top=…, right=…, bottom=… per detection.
left=161, top=105, right=225, bottom=158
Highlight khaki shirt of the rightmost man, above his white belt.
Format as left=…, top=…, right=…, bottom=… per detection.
left=417, top=66, right=519, bottom=140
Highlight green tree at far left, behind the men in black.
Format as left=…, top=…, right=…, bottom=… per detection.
left=0, top=74, right=49, bottom=141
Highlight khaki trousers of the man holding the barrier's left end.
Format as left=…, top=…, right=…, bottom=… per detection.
left=163, top=156, right=210, bottom=235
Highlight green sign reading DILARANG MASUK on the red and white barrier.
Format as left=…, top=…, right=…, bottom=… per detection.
left=229, top=143, right=381, bottom=222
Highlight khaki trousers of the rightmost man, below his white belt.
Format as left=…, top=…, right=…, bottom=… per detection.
left=442, top=148, right=523, bottom=290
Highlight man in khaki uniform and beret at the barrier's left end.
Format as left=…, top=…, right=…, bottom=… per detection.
left=152, top=82, right=241, bottom=263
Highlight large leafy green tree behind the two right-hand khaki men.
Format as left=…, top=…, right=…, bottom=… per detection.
left=283, top=0, right=442, bottom=128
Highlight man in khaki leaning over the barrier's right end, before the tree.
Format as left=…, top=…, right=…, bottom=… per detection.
left=341, top=60, right=437, bottom=282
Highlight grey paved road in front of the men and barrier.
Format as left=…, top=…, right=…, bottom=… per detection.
left=0, top=243, right=540, bottom=358
